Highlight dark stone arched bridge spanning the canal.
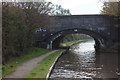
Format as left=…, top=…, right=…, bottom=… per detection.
left=36, top=14, right=120, bottom=49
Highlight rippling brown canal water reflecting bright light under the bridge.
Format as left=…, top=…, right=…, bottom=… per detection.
left=50, top=40, right=120, bottom=80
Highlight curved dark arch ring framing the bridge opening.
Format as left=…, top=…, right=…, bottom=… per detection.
left=46, top=29, right=105, bottom=48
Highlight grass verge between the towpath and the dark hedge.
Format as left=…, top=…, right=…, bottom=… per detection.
left=2, top=48, right=51, bottom=77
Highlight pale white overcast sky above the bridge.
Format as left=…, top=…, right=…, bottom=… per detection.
left=46, top=0, right=103, bottom=15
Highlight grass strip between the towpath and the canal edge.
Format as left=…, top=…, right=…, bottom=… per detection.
left=25, top=50, right=62, bottom=78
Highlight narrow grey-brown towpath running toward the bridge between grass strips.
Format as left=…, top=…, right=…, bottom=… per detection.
left=5, top=50, right=58, bottom=78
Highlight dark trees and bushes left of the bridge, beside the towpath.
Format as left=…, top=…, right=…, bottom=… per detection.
left=2, top=1, right=70, bottom=62
